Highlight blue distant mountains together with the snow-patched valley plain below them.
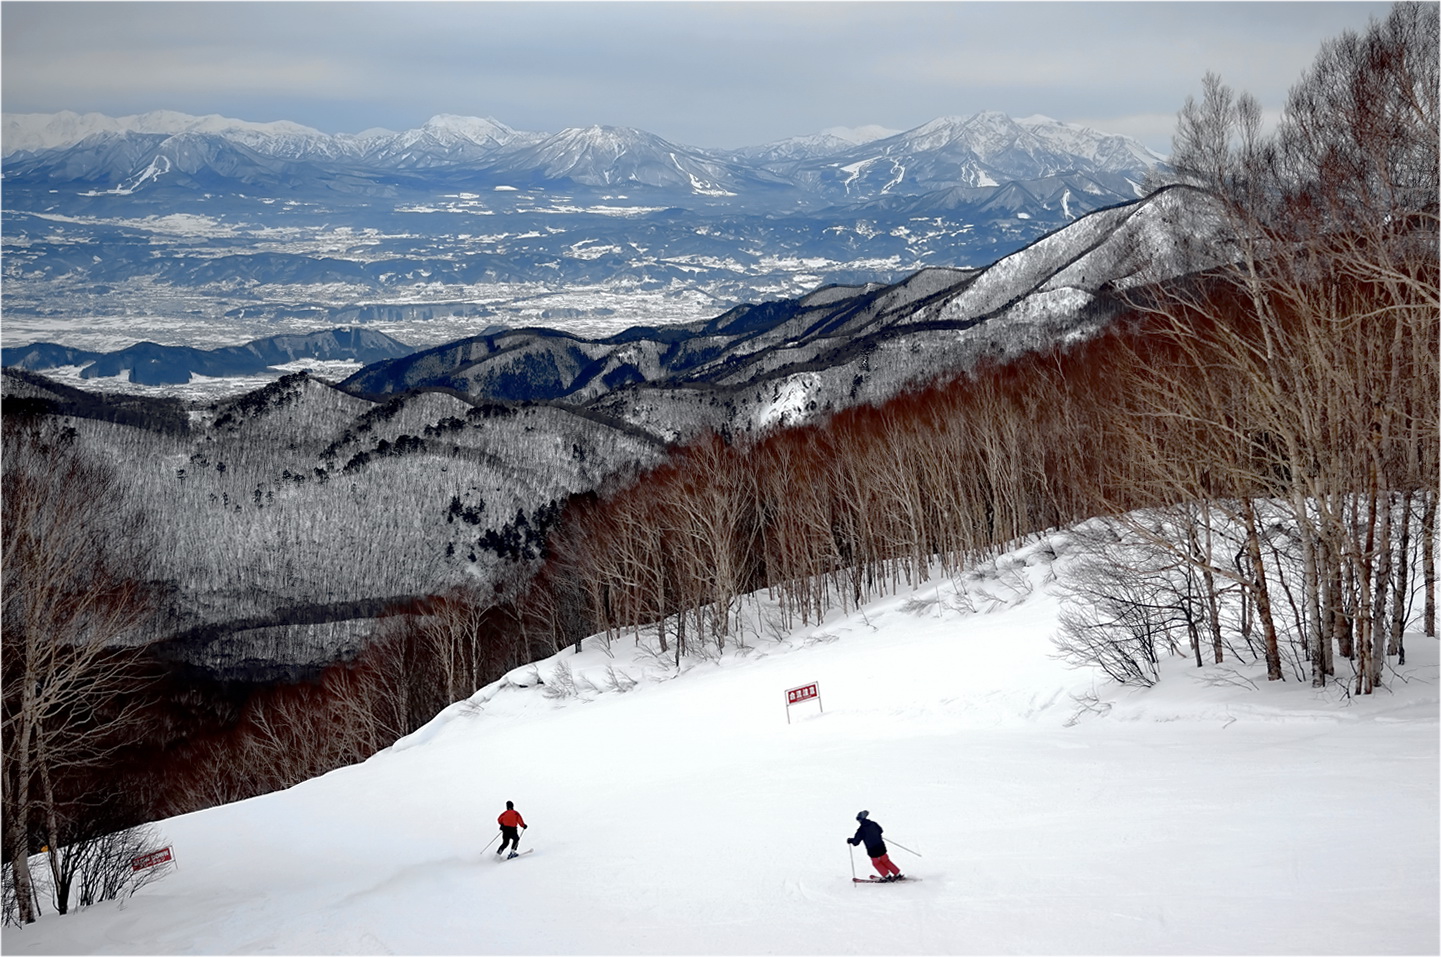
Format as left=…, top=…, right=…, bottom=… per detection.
left=0, top=112, right=1164, bottom=376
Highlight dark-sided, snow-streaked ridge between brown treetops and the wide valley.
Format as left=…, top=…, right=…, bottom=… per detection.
left=344, top=187, right=1219, bottom=437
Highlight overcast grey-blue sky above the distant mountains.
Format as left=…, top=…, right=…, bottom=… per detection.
left=0, top=0, right=1389, bottom=153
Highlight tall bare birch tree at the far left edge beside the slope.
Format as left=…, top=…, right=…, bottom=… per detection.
left=0, top=419, right=156, bottom=922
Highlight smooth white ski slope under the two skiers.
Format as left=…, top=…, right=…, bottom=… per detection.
left=3, top=539, right=1438, bottom=954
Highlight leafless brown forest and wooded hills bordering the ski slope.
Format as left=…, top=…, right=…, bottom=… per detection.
left=3, top=4, right=1441, bottom=922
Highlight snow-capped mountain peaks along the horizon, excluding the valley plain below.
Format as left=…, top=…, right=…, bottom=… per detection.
left=0, top=112, right=1163, bottom=200
